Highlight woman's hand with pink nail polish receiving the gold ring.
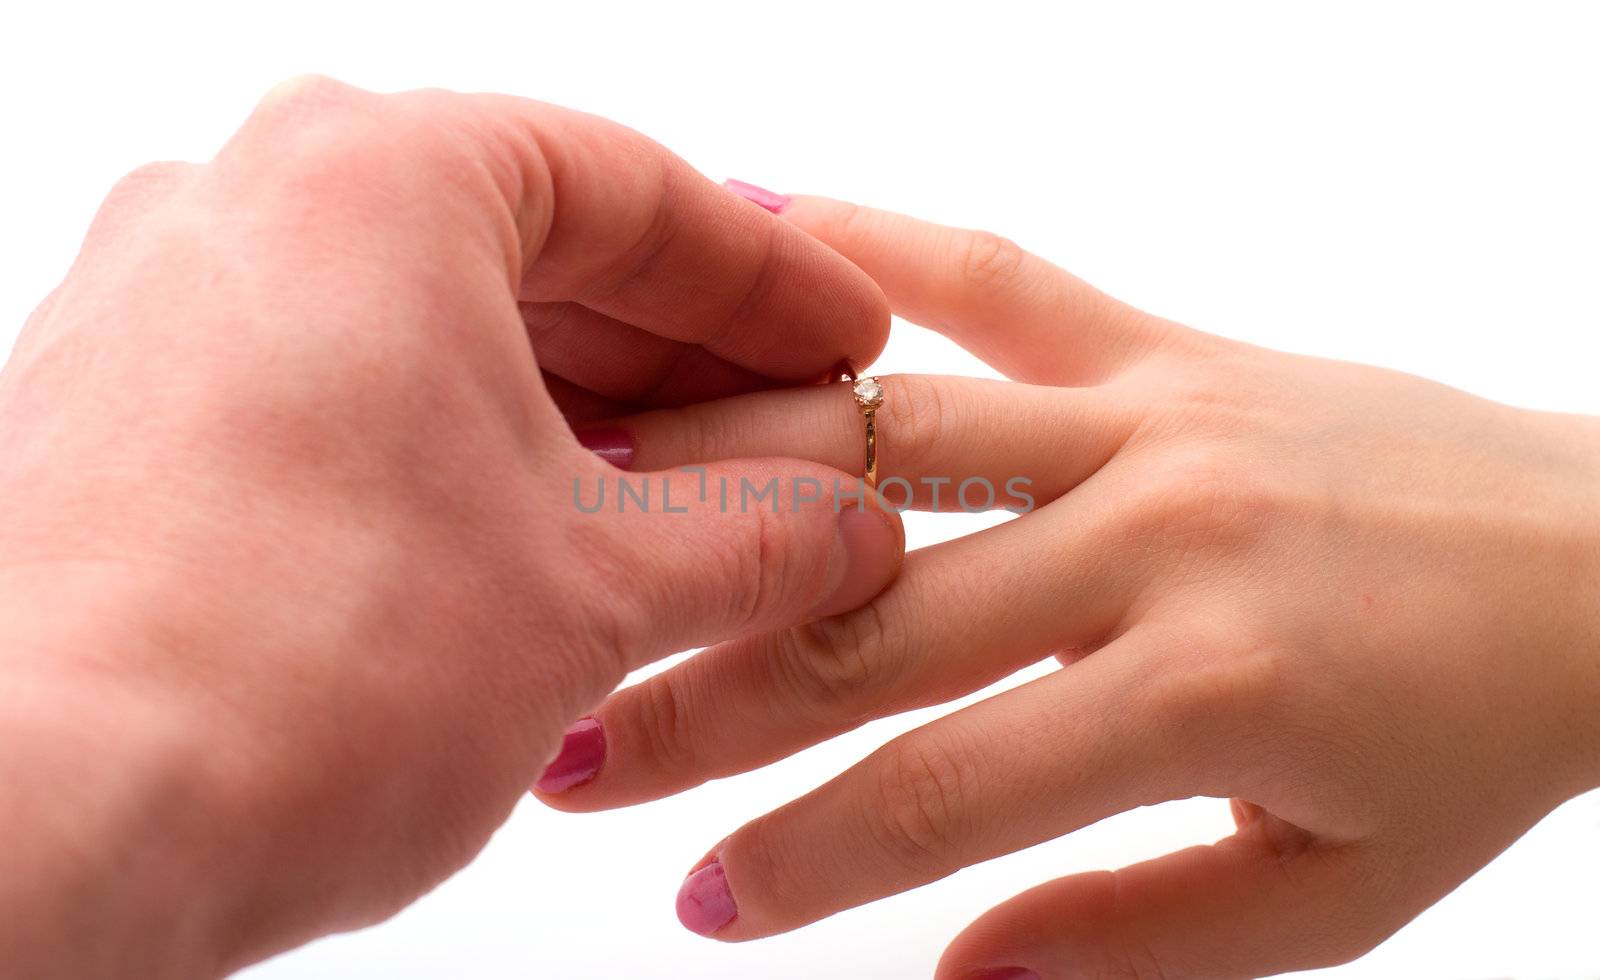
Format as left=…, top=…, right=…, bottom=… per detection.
left=546, top=199, right=1600, bottom=980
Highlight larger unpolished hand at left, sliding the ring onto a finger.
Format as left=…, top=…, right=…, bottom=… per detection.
left=0, top=86, right=902, bottom=977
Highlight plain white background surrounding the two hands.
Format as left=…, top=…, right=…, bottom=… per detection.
left=0, top=0, right=1600, bottom=980
